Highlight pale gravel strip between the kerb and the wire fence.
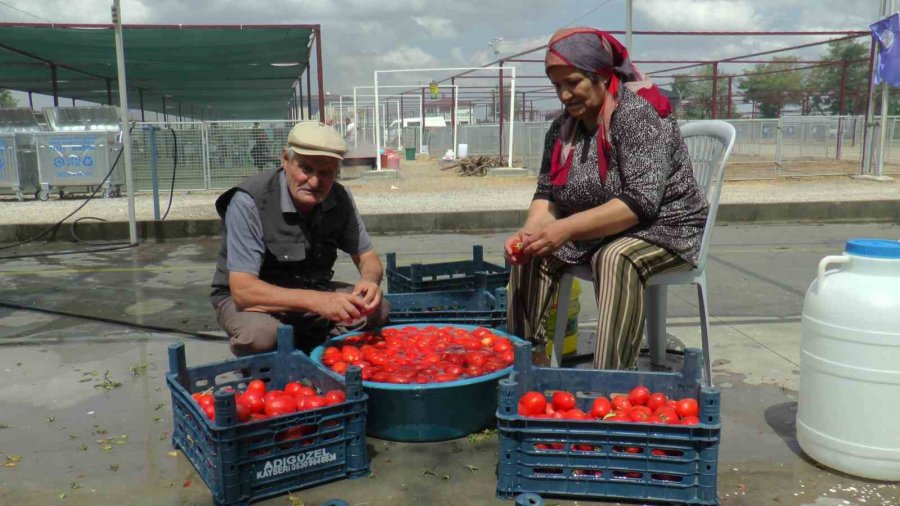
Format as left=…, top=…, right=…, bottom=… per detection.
left=0, top=162, right=900, bottom=224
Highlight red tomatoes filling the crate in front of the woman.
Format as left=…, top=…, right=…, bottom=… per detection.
left=519, top=386, right=700, bottom=425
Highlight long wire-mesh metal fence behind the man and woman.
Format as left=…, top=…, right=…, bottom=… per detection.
left=121, top=116, right=900, bottom=191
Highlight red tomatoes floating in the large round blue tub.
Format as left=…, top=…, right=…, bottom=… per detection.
left=322, top=325, right=515, bottom=384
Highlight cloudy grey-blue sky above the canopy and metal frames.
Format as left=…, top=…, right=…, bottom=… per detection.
left=0, top=0, right=893, bottom=113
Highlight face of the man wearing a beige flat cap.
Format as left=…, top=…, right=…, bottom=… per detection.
left=281, top=151, right=341, bottom=213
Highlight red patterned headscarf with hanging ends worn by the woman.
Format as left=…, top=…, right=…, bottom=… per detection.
left=544, top=28, right=672, bottom=185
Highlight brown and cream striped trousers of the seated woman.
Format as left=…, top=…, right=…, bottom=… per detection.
left=507, top=237, right=691, bottom=369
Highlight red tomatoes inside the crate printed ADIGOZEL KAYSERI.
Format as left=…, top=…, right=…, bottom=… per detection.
left=191, top=379, right=347, bottom=422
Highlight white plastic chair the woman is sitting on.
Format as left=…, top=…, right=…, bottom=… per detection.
left=550, top=120, right=736, bottom=385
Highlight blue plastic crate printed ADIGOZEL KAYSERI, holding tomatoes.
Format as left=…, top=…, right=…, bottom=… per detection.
left=166, top=325, right=369, bottom=504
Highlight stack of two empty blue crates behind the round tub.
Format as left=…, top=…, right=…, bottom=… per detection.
left=385, top=245, right=509, bottom=327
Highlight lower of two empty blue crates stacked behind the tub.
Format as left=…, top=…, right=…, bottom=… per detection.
left=384, top=278, right=506, bottom=327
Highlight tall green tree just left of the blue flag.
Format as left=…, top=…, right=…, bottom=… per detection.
left=807, top=40, right=869, bottom=114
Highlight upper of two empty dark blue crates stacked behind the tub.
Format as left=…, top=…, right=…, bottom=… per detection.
left=385, top=245, right=509, bottom=293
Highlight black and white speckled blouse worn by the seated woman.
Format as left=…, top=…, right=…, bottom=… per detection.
left=534, top=89, right=709, bottom=265
